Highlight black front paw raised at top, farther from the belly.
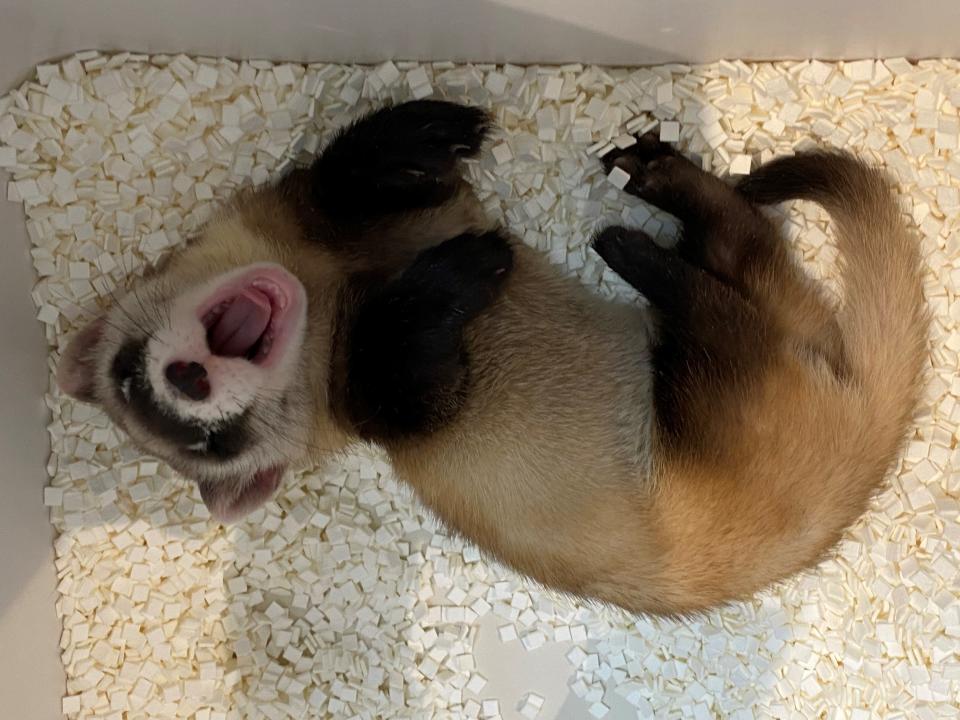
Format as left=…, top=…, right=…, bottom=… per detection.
left=309, top=100, right=490, bottom=221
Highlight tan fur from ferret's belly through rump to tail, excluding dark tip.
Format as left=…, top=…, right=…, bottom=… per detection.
left=392, top=162, right=927, bottom=614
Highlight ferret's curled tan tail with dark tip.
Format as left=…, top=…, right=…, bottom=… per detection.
left=738, top=151, right=929, bottom=434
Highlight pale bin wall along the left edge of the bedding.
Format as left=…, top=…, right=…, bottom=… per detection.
left=0, top=193, right=63, bottom=718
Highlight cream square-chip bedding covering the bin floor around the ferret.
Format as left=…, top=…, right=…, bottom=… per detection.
left=0, top=53, right=960, bottom=720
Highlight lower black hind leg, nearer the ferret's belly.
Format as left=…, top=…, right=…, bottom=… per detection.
left=593, top=227, right=780, bottom=454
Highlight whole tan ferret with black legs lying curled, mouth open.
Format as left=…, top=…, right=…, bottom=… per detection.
left=59, top=101, right=927, bottom=614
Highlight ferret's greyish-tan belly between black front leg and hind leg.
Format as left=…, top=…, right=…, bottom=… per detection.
left=388, top=247, right=653, bottom=592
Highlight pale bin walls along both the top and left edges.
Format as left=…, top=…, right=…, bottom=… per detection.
left=0, top=0, right=960, bottom=720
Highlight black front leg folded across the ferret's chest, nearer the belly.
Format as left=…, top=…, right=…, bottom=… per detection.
left=347, top=232, right=513, bottom=441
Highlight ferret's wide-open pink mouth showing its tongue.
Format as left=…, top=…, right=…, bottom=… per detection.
left=198, top=268, right=300, bottom=367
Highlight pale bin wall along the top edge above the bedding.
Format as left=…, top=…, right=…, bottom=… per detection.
left=0, top=0, right=960, bottom=86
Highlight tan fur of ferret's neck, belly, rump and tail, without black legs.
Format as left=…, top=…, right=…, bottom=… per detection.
left=63, top=155, right=926, bottom=614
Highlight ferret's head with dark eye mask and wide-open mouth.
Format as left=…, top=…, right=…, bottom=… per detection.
left=58, top=202, right=346, bottom=521
